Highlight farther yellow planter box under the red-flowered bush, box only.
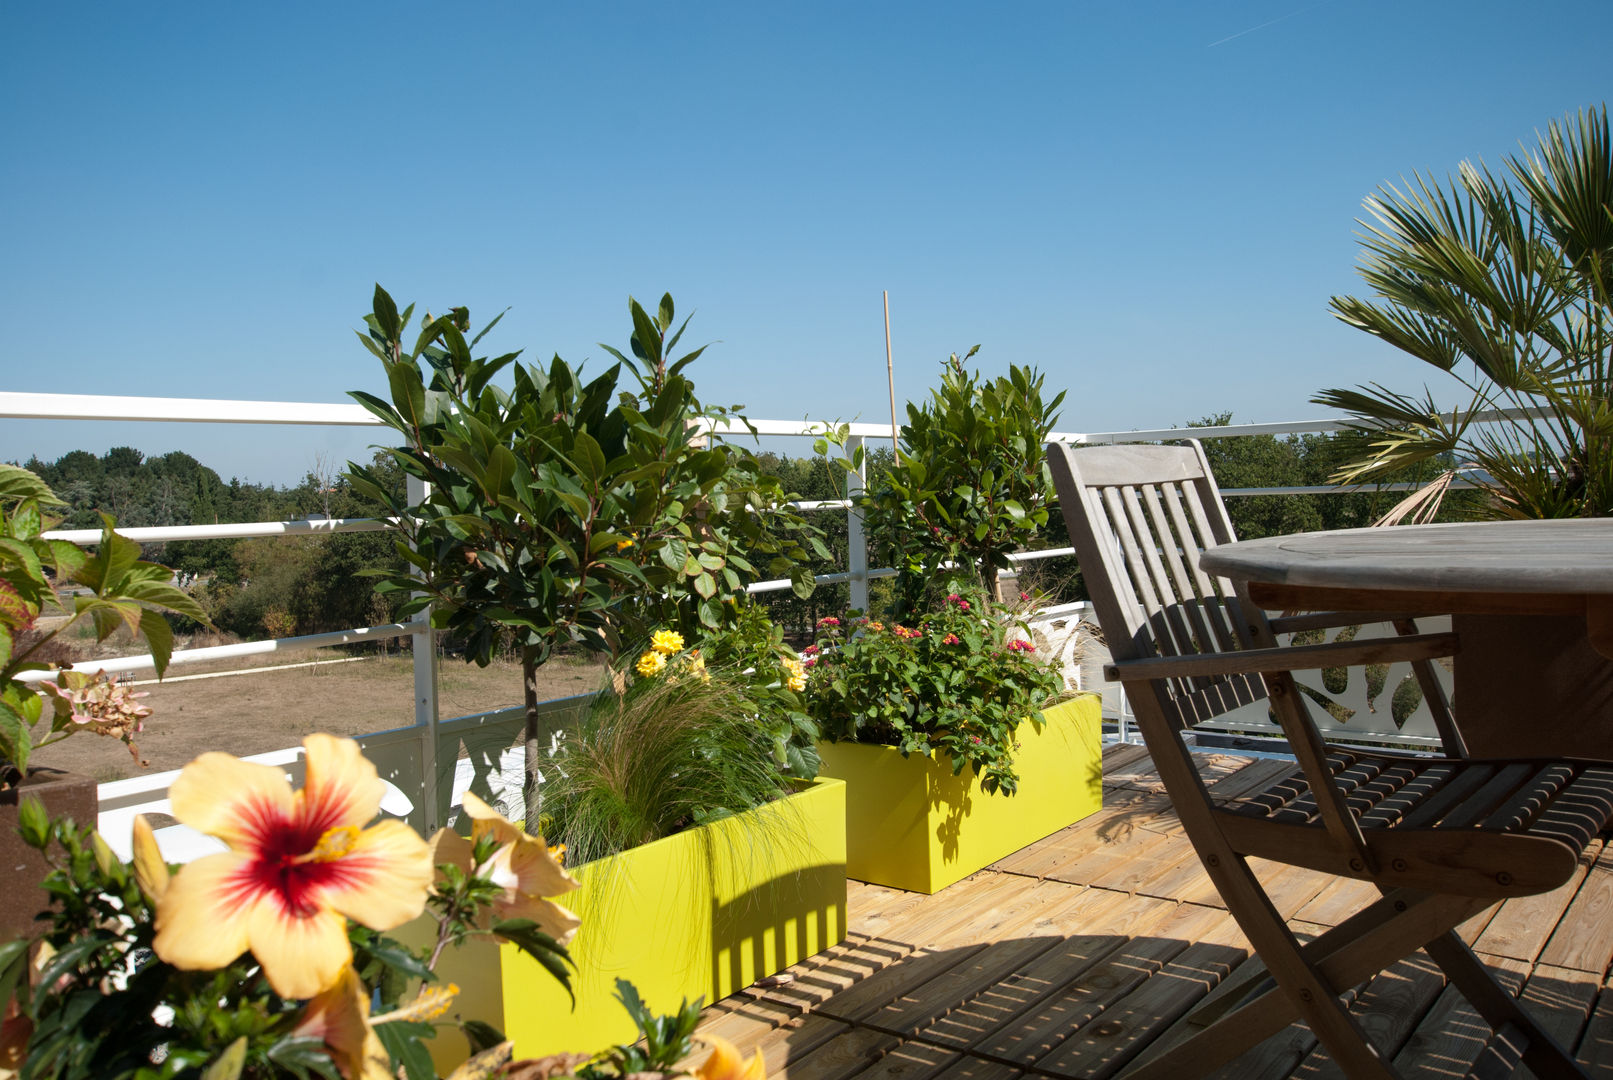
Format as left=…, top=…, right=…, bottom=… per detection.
left=818, top=695, right=1103, bottom=893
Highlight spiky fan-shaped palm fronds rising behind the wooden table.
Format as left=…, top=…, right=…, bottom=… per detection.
left=1313, top=105, right=1613, bottom=517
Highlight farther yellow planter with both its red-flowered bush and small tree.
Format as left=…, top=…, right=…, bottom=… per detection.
left=807, top=354, right=1102, bottom=893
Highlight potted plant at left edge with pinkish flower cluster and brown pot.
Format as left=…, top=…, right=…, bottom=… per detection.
left=0, top=464, right=206, bottom=943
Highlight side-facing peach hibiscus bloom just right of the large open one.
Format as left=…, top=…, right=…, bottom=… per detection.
left=431, top=791, right=581, bottom=945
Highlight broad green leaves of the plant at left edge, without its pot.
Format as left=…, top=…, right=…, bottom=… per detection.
left=0, top=464, right=205, bottom=787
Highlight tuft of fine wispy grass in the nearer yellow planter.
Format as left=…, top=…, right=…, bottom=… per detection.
left=544, top=672, right=782, bottom=866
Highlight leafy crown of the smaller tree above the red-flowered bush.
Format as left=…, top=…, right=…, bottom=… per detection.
left=818, top=353, right=1065, bottom=611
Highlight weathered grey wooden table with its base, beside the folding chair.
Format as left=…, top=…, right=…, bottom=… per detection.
left=1200, top=519, right=1613, bottom=759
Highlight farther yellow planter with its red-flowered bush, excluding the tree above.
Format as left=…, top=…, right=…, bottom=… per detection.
left=805, top=592, right=1103, bottom=893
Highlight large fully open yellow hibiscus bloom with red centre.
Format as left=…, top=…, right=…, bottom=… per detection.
left=152, top=735, right=432, bottom=998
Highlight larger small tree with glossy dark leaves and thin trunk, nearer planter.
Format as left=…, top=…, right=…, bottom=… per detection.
left=348, top=285, right=819, bottom=832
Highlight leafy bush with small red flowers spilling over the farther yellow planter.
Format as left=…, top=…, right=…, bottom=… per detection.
left=807, top=593, right=1061, bottom=795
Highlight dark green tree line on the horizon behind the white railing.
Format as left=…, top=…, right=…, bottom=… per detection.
left=12, top=428, right=1476, bottom=651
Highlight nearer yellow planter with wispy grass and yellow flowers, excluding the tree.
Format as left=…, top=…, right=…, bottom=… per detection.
left=435, top=630, right=845, bottom=1054
